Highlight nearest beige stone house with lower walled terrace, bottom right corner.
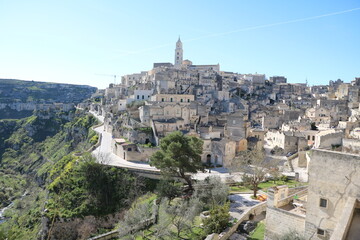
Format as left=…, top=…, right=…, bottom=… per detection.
left=265, top=149, right=360, bottom=240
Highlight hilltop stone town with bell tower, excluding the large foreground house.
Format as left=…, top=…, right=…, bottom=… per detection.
left=88, top=39, right=360, bottom=167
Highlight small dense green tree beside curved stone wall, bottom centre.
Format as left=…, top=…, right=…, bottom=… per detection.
left=204, top=203, right=230, bottom=234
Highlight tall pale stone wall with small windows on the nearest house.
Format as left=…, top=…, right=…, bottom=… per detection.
left=305, top=149, right=360, bottom=239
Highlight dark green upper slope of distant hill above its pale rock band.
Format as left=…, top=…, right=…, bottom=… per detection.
left=0, top=79, right=97, bottom=104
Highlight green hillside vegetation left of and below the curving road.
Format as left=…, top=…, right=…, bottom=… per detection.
left=0, top=109, right=153, bottom=239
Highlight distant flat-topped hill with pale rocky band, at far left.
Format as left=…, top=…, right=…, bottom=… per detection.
left=0, top=79, right=96, bottom=119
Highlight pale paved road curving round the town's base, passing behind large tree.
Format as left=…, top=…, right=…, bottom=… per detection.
left=90, top=112, right=241, bottom=181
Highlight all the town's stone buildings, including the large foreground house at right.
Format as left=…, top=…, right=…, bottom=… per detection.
left=86, top=38, right=360, bottom=239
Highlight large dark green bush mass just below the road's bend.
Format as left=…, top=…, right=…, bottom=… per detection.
left=47, top=157, right=148, bottom=217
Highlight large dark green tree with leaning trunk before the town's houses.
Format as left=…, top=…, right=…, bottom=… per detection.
left=150, top=131, right=204, bottom=190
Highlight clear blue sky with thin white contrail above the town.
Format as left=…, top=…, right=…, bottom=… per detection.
left=0, top=0, right=360, bottom=88
